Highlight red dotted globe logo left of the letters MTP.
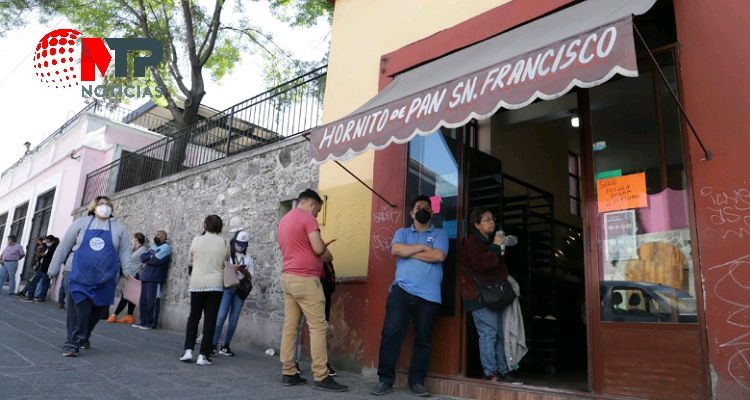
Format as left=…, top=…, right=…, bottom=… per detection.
left=34, top=29, right=81, bottom=89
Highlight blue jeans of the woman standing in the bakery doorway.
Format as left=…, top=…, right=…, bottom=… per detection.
left=471, top=307, right=509, bottom=375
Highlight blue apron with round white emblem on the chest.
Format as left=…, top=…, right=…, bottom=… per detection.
left=68, top=217, right=120, bottom=306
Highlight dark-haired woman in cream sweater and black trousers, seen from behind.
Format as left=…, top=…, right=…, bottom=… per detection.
left=180, top=215, right=230, bottom=366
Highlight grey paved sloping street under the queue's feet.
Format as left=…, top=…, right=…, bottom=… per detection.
left=0, top=291, right=452, bottom=400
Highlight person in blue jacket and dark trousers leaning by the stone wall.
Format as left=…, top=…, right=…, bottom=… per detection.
left=133, top=229, right=172, bottom=330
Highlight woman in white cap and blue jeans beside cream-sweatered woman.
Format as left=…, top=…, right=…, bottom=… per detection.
left=213, top=231, right=255, bottom=357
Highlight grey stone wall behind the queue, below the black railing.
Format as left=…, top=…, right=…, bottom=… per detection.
left=89, top=138, right=318, bottom=352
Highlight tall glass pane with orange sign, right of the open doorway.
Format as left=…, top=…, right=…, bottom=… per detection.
left=590, top=48, right=697, bottom=323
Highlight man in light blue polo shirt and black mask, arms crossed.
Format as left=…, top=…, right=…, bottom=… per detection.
left=371, top=196, right=448, bottom=397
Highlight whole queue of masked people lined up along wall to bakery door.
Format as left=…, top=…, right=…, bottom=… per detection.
left=0, top=189, right=526, bottom=397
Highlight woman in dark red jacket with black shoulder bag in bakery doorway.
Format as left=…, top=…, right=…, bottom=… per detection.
left=461, top=207, right=523, bottom=384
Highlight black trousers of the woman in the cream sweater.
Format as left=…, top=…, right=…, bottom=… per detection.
left=185, top=292, right=224, bottom=356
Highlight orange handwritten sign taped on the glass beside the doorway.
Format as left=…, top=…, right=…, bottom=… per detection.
left=596, top=172, right=648, bottom=213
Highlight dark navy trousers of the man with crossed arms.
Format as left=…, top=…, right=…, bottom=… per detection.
left=378, top=286, right=440, bottom=385
